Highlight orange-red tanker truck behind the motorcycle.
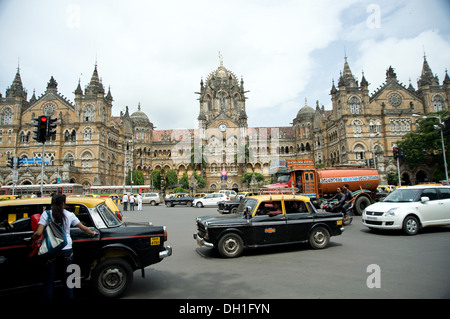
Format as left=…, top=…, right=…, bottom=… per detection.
left=261, top=159, right=380, bottom=215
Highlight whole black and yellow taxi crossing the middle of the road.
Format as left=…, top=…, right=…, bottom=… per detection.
left=194, top=195, right=344, bottom=258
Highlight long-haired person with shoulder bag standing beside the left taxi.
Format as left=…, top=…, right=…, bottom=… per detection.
left=32, top=194, right=97, bottom=299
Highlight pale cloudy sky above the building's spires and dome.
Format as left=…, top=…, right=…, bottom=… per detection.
left=0, top=0, right=450, bottom=129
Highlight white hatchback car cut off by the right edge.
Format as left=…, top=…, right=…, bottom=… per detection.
left=362, top=186, right=450, bottom=235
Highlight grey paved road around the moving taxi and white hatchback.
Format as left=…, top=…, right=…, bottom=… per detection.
left=124, top=205, right=450, bottom=299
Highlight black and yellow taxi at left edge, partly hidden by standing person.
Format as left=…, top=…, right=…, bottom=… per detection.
left=0, top=197, right=172, bottom=297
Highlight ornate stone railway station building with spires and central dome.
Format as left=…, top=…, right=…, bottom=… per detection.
left=0, top=57, right=450, bottom=191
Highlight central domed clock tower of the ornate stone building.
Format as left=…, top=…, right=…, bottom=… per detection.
left=196, top=53, right=248, bottom=189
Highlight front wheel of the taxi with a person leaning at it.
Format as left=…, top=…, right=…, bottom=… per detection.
left=92, top=258, right=133, bottom=298
